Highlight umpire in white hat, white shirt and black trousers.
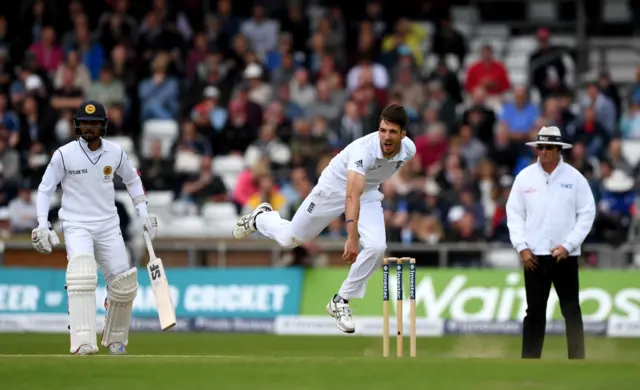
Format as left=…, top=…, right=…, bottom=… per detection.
left=507, top=126, right=596, bottom=359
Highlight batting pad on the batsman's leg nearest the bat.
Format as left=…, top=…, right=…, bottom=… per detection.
left=102, top=268, right=138, bottom=347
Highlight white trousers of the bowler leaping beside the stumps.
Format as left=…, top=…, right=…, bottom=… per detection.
left=256, top=184, right=387, bottom=299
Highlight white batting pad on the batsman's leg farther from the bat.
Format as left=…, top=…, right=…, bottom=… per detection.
left=66, top=254, right=98, bottom=353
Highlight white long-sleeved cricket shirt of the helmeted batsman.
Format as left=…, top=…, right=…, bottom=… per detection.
left=36, top=139, right=144, bottom=227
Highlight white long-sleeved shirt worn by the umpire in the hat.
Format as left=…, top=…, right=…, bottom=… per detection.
left=507, top=158, right=596, bottom=256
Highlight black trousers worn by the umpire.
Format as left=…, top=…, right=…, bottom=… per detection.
left=522, top=256, right=585, bottom=359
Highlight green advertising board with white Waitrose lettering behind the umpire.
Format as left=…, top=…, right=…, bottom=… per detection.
left=300, top=268, right=640, bottom=322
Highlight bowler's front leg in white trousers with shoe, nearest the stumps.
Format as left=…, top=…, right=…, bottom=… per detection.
left=326, top=201, right=387, bottom=333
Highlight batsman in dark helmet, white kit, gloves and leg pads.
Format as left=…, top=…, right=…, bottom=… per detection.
left=31, top=101, right=158, bottom=355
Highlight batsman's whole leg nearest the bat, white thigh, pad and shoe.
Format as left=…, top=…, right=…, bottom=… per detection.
left=92, top=217, right=138, bottom=355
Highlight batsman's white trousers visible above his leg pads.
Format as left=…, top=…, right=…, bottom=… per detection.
left=61, top=215, right=131, bottom=286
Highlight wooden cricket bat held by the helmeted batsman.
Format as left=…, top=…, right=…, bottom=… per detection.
left=142, top=230, right=176, bottom=331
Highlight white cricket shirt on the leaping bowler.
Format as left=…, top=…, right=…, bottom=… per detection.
left=318, top=132, right=416, bottom=194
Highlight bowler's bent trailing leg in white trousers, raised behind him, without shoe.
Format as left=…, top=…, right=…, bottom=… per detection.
left=256, top=192, right=344, bottom=248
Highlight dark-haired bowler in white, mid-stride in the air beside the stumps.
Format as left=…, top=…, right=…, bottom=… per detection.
left=233, top=104, right=416, bottom=333
